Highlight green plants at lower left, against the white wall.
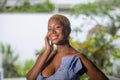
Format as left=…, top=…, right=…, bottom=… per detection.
left=0, top=43, right=34, bottom=78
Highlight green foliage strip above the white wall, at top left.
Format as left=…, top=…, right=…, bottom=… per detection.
left=0, top=0, right=55, bottom=13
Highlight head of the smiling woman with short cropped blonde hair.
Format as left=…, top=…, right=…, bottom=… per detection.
left=48, top=15, right=71, bottom=44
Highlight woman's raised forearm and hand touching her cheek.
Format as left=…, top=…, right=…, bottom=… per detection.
left=27, top=36, right=53, bottom=80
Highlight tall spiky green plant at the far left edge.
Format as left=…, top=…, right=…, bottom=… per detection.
left=0, top=43, right=19, bottom=77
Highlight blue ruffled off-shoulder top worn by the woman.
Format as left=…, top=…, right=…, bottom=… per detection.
left=37, top=55, right=82, bottom=80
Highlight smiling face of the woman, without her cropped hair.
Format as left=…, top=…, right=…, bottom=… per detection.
left=47, top=19, right=64, bottom=45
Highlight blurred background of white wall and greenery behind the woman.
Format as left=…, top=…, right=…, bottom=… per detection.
left=0, top=0, right=120, bottom=80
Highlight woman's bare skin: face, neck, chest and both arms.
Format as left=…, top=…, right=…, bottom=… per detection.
left=27, top=19, right=108, bottom=80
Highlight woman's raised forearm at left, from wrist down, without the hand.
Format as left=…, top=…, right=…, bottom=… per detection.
left=27, top=50, right=50, bottom=80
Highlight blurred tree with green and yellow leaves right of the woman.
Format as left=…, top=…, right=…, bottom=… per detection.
left=71, top=0, right=120, bottom=76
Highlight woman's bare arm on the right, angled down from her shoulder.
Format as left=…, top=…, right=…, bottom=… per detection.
left=78, top=53, right=108, bottom=80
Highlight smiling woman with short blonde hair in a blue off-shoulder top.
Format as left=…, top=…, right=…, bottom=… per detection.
left=27, top=14, right=108, bottom=80
